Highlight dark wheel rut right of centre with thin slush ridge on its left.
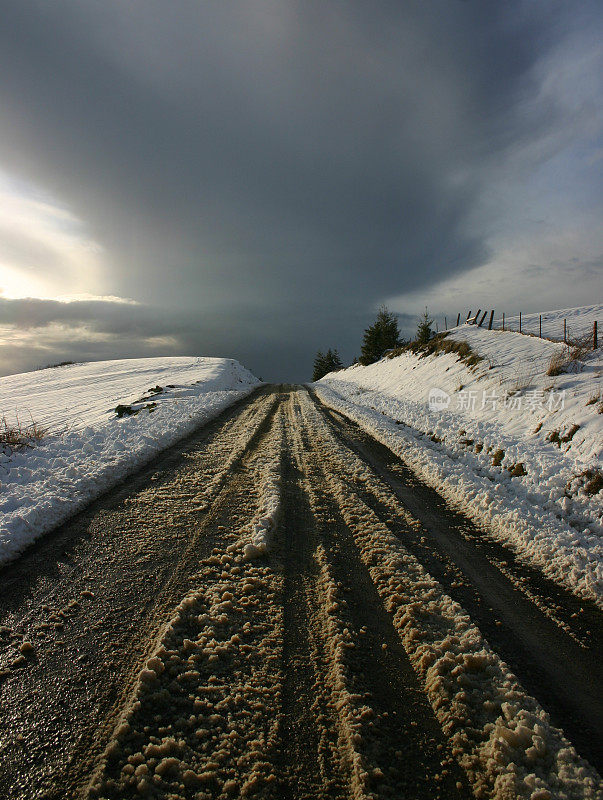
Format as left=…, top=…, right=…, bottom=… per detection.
left=280, top=395, right=469, bottom=799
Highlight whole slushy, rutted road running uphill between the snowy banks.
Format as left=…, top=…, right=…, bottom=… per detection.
left=0, top=387, right=603, bottom=800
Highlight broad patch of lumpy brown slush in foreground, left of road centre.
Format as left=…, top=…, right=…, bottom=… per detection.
left=89, top=549, right=282, bottom=800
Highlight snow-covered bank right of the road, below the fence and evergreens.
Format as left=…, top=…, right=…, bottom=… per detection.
left=315, top=306, right=603, bottom=602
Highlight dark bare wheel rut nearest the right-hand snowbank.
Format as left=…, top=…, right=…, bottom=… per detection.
left=312, top=388, right=603, bottom=769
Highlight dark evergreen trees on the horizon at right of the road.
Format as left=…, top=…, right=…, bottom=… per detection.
left=312, top=306, right=433, bottom=381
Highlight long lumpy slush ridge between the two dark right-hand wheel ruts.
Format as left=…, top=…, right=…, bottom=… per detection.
left=292, top=384, right=601, bottom=798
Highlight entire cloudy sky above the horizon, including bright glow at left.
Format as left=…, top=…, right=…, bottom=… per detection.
left=0, top=0, right=603, bottom=381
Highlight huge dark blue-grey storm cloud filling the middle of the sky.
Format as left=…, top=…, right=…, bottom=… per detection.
left=0, top=0, right=600, bottom=379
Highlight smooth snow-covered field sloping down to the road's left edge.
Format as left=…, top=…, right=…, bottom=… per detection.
left=0, top=357, right=259, bottom=564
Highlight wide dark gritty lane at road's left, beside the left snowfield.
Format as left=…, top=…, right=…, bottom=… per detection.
left=0, top=392, right=280, bottom=798
